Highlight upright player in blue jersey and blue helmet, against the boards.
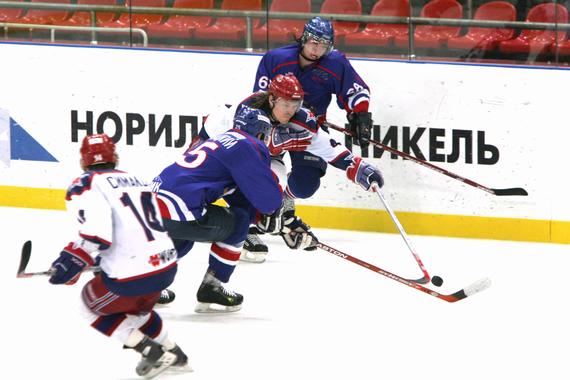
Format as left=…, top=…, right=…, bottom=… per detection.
left=242, top=17, right=372, bottom=261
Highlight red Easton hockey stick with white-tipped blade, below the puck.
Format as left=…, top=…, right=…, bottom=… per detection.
left=317, top=242, right=491, bottom=302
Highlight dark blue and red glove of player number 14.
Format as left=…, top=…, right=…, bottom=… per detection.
left=49, top=243, right=94, bottom=285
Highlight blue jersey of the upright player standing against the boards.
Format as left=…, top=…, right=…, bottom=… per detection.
left=253, top=44, right=370, bottom=116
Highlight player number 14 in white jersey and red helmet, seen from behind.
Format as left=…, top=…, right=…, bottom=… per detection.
left=49, top=134, right=190, bottom=378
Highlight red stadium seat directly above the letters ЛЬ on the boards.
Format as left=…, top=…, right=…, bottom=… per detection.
left=447, top=0, right=517, bottom=51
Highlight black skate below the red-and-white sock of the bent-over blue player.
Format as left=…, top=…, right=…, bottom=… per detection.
left=194, top=272, right=243, bottom=313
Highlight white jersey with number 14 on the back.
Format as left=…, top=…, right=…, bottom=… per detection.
left=66, top=170, right=176, bottom=282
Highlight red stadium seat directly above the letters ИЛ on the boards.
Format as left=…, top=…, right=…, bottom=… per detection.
left=146, top=0, right=214, bottom=38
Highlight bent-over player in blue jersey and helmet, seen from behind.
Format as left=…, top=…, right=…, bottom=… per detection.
left=154, top=106, right=307, bottom=312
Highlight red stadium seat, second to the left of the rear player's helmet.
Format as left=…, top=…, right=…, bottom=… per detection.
left=193, top=0, right=261, bottom=41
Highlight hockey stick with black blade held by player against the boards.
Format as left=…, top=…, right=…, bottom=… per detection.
left=324, top=121, right=528, bottom=196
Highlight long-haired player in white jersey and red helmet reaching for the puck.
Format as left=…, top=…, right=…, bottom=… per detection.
left=182, top=74, right=383, bottom=268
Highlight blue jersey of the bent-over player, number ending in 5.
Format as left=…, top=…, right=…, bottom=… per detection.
left=154, top=129, right=282, bottom=221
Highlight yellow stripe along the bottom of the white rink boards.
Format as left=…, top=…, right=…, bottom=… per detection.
left=0, top=186, right=570, bottom=244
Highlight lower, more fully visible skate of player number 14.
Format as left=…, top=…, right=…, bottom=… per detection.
left=134, top=336, right=178, bottom=379
